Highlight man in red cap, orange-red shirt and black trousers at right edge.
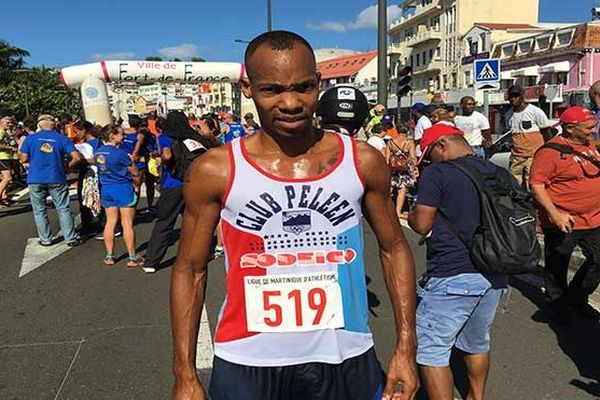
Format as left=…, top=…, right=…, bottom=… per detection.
left=529, top=107, right=600, bottom=314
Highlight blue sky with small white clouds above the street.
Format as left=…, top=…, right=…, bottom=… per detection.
left=0, top=0, right=600, bottom=67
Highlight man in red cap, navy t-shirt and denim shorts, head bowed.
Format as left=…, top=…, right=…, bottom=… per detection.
left=408, top=124, right=506, bottom=399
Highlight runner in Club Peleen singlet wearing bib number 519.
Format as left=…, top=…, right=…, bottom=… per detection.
left=171, top=31, right=418, bottom=400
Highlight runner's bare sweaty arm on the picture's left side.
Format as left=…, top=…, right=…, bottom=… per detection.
left=170, top=147, right=229, bottom=399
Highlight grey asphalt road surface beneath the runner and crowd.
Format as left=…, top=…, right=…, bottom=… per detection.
left=0, top=198, right=600, bottom=400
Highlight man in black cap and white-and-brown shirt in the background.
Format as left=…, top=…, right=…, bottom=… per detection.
left=505, top=85, right=550, bottom=186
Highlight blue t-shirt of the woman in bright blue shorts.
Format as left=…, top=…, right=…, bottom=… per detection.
left=94, top=145, right=133, bottom=185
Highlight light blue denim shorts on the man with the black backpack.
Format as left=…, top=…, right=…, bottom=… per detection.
left=417, top=273, right=507, bottom=367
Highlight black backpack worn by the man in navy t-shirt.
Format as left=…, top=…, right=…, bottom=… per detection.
left=440, top=160, right=541, bottom=275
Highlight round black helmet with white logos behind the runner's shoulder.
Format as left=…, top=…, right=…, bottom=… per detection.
left=316, top=86, right=369, bottom=136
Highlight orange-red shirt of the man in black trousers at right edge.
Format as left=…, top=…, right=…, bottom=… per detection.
left=529, top=136, right=600, bottom=229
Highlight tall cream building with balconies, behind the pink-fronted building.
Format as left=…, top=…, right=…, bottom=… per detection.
left=388, top=0, right=539, bottom=94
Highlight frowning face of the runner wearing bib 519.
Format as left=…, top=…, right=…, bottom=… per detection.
left=244, top=43, right=319, bottom=138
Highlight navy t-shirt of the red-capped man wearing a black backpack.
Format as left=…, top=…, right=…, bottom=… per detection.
left=417, top=157, right=498, bottom=277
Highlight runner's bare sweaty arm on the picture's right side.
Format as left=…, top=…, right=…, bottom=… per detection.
left=357, top=143, right=419, bottom=399
